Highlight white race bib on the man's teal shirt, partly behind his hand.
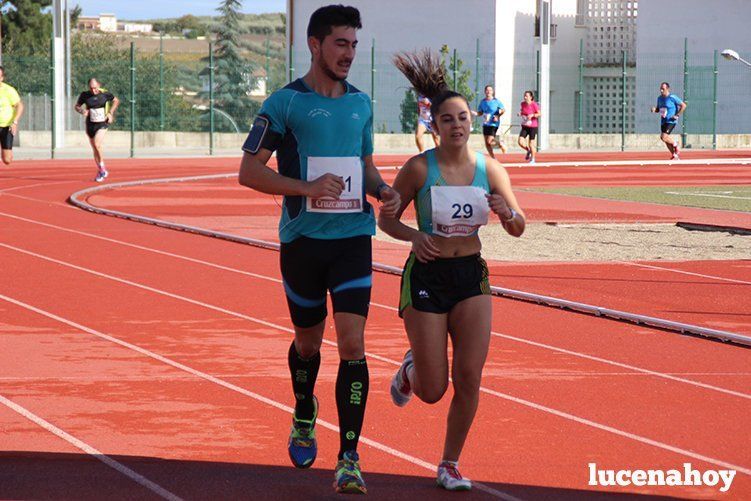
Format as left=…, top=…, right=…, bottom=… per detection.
left=305, top=157, right=363, bottom=214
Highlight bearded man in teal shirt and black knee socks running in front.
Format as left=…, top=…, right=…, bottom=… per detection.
left=239, top=5, right=400, bottom=493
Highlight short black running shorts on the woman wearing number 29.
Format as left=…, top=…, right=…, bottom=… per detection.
left=399, top=253, right=490, bottom=317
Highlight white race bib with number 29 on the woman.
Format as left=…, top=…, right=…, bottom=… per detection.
left=430, top=186, right=490, bottom=237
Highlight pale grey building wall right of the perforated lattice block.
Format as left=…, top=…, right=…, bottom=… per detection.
left=636, top=0, right=751, bottom=134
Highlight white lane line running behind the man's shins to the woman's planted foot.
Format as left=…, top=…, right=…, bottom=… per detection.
left=0, top=294, right=518, bottom=501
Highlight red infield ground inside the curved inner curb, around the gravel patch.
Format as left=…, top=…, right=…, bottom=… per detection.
left=82, top=159, right=751, bottom=335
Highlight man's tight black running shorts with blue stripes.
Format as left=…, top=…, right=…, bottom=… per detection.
left=279, top=235, right=373, bottom=328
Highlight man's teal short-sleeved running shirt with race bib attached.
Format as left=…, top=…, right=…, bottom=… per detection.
left=243, top=78, right=375, bottom=243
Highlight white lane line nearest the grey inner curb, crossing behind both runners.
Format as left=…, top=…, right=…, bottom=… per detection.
left=0, top=212, right=751, bottom=399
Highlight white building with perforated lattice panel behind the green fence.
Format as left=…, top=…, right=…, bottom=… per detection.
left=287, top=0, right=751, bottom=137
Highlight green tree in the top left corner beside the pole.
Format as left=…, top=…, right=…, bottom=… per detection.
left=0, top=0, right=52, bottom=56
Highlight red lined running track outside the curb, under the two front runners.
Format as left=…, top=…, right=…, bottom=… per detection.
left=0, top=160, right=751, bottom=499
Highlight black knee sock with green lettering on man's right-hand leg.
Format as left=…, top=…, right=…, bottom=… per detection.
left=336, top=358, right=368, bottom=459
